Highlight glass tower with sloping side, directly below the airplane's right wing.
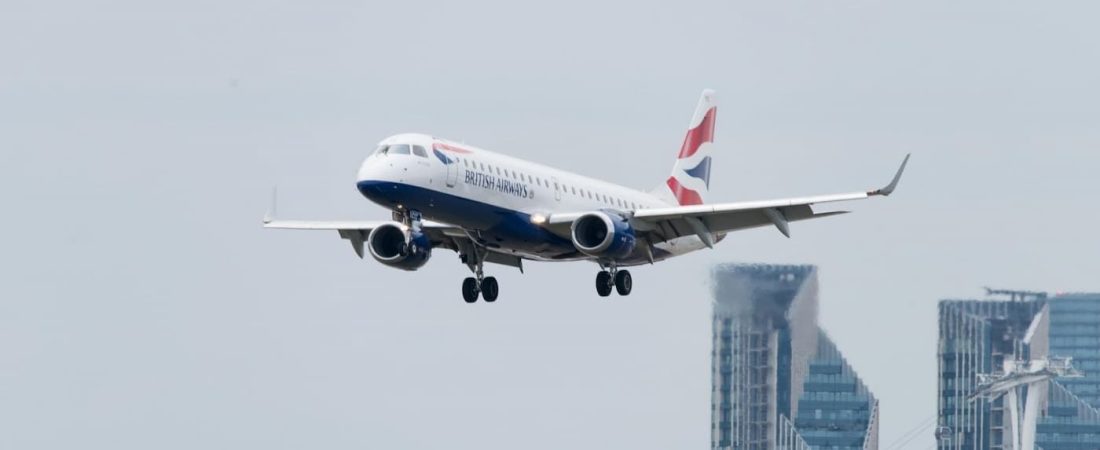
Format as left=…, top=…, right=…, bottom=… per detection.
left=711, top=264, right=879, bottom=450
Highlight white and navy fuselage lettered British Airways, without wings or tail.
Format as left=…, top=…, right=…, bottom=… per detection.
left=358, top=134, right=704, bottom=260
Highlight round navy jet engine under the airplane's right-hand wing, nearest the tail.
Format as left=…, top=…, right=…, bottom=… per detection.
left=570, top=211, right=635, bottom=259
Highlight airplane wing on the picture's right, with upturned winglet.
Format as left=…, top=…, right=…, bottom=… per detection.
left=549, top=155, right=909, bottom=246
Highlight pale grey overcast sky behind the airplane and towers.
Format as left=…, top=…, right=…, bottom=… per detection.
left=0, top=0, right=1100, bottom=449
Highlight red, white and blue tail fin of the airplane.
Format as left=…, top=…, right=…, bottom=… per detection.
left=651, top=89, right=718, bottom=206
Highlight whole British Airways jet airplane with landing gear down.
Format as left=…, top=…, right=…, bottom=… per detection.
left=264, top=90, right=909, bottom=303
